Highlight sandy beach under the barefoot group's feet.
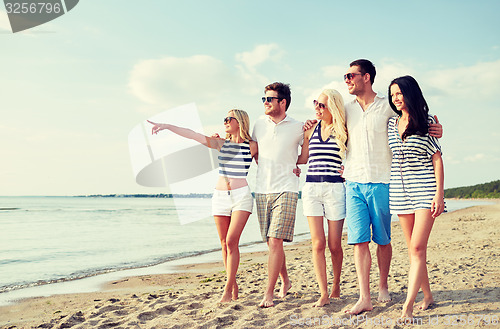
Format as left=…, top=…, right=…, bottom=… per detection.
left=0, top=203, right=500, bottom=328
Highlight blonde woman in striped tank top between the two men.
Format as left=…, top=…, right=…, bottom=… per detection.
left=297, top=89, right=347, bottom=307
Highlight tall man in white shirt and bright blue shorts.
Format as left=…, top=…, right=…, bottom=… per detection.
left=343, top=59, right=442, bottom=314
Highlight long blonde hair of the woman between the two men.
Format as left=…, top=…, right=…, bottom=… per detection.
left=321, top=89, right=347, bottom=159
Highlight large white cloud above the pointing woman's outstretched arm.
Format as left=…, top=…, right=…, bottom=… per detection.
left=128, top=44, right=288, bottom=119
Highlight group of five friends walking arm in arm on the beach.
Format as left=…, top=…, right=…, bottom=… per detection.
left=150, top=59, right=445, bottom=318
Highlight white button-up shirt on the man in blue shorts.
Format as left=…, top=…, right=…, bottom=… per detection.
left=343, top=95, right=396, bottom=184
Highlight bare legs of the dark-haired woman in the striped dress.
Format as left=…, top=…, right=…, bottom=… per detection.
left=399, top=209, right=434, bottom=318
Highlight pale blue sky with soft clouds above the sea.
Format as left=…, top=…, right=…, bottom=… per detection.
left=0, top=0, right=500, bottom=196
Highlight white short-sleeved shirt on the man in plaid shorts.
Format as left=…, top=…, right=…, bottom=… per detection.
left=252, top=115, right=304, bottom=193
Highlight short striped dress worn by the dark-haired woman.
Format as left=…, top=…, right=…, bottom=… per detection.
left=388, top=115, right=441, bottom=214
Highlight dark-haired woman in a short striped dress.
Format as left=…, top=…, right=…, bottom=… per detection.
left=388, top=76, right=445, bottom=318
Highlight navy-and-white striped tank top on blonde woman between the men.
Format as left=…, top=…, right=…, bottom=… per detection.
left=306, top=121, right=343, bottom=183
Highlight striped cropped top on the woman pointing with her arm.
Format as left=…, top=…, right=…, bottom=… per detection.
left=219, top=140, right=252, bottom=178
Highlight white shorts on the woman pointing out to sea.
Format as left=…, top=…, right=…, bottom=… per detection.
left=212, top=185, right=253, bottom=216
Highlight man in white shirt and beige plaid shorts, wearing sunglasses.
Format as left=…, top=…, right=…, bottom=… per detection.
left=252, top=82, right=304, bottom=307
